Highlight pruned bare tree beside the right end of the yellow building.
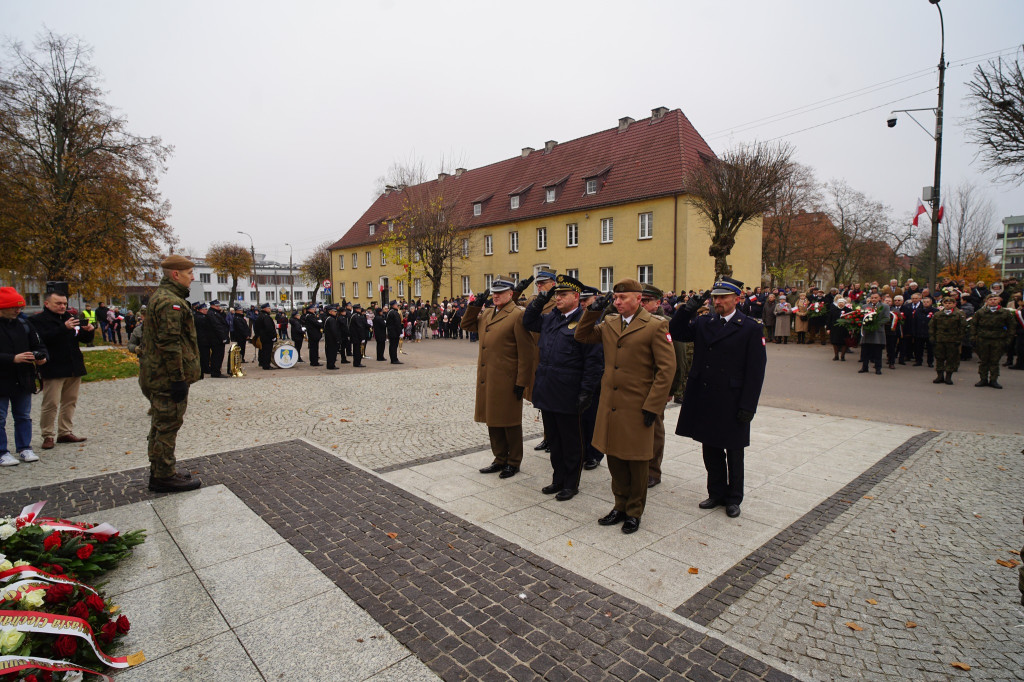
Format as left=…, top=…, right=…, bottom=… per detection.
left=684, top=142, right=793, bottom=278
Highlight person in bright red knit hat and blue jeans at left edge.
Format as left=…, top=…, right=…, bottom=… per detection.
left=0, top=287, right=46, bottom=467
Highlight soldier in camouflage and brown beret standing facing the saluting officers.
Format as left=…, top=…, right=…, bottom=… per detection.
left=138, top=255, right=202, bottom=493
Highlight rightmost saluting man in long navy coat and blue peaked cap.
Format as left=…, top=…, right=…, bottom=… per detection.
left=670, top=278, right=767, bottom=518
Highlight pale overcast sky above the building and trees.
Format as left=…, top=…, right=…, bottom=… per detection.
left=0, top=0, right=1024, bottom=262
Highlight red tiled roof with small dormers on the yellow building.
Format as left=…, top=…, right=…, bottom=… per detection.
left=331, top=109, right=715, bottom=249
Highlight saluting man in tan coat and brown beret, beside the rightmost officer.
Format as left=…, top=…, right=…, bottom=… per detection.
left=575, top=279, right=676, bottom=534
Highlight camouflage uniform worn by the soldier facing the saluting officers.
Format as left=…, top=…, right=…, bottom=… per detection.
left=138, top=276, right=202, bottom=478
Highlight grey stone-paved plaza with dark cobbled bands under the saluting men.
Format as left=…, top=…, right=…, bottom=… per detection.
left=0, top=341, right=1024, bottom=680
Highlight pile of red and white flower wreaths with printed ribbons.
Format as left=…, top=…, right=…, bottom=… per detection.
left=0, top=502, right=145, bottom=682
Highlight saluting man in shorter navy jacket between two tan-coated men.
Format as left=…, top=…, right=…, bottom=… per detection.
left=522, top=274, right=604, bottom=502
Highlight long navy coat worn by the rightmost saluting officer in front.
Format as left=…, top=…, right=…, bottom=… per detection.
left=669, top=308, right=768, bottom=447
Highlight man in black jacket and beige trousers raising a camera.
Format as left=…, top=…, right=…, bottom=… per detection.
left=29, top=287, right=95, bottom=450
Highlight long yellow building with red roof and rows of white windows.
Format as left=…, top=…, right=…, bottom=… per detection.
left=331, top=108, right=761, bottom=305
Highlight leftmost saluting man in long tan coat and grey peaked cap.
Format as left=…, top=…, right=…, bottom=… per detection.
left=461, top=278, right=537, bottom=478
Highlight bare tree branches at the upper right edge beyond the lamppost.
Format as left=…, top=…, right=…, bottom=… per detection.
left=967, top=59, right=1024, bottom=185
